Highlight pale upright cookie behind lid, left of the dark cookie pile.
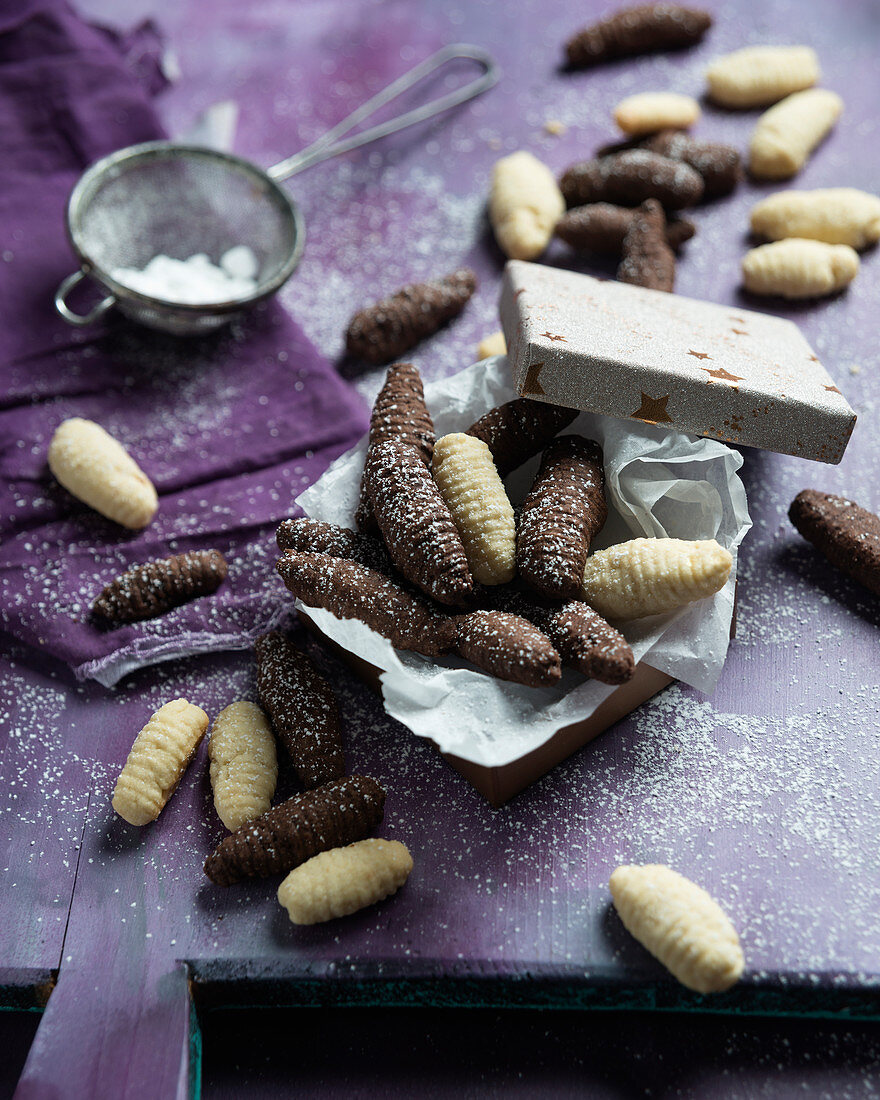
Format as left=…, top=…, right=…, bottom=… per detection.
left=488, top=151, right=565, bottom=260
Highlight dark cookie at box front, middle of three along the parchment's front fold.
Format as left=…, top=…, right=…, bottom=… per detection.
left=454, top=611, right=562, bottom=688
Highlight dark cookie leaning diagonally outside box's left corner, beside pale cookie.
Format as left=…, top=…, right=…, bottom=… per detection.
left=254, top=630, right=345, bottom=788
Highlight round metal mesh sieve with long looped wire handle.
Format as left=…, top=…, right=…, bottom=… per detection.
left=55, top=44, right=498, bottom=334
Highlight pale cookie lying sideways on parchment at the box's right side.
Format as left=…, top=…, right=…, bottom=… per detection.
left=582, top=539, right=733, bottom=622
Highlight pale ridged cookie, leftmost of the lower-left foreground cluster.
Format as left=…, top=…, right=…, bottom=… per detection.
left=113, top=699, right=208, bottom=825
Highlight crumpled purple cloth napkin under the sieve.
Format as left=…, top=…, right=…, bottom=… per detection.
left=0, top=0, right=366, bottom=684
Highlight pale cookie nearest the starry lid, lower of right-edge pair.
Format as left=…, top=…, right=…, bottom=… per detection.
left=743, top=237, right=859, bottom=298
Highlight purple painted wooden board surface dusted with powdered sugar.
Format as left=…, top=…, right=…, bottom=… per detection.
left=0, top=0, right=880, bottom=1098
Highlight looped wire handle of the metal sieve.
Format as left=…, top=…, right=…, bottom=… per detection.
left=267, top=43, right=501, bottom=180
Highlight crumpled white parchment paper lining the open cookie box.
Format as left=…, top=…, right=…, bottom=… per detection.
left=297, top=355, right=751, bottom=767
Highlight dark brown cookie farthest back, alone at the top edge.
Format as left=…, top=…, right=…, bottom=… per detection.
left=565, top=3, right=712, bottom=68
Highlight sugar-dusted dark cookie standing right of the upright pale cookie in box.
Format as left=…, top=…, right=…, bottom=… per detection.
left=516, top=436, right=608, bottom=600
